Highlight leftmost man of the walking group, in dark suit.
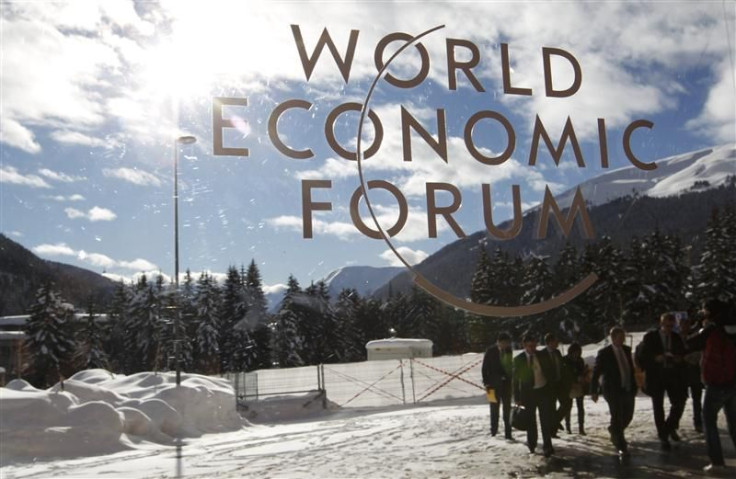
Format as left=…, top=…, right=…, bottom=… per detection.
left=482, top=332, right=513, bottom=440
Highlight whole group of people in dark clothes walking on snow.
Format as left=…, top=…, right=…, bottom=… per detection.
left=482, top=300, right=736, bottom=472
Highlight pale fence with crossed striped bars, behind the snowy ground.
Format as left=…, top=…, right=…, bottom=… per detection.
left=228, top=353, right=484, bottom=407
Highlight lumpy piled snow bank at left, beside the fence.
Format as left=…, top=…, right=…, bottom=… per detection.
left=0, top=369, right=244, bottom=463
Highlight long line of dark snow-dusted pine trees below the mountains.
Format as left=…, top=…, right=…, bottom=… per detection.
left=24, top=208, right=736, bottom=385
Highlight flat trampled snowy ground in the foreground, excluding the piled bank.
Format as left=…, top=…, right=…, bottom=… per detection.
left=2, top=397, right=736, bottom=479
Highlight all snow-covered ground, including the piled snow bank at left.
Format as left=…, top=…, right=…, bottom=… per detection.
left=0, top=335, right=736, bottom=479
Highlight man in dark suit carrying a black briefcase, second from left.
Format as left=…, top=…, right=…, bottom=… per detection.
left=513, top=334, right=555, bottom=457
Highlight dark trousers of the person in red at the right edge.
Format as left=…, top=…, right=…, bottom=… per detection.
left=703, top=386, right=736, bottom=466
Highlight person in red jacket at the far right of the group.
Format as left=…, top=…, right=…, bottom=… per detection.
left=688, top=300, right=736, bottom=474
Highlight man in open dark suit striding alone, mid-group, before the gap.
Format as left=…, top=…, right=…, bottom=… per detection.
left=590, top=326, right=636, bottom=455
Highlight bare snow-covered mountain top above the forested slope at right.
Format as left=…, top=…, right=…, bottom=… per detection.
left=557, top=145, right=736, bottom=206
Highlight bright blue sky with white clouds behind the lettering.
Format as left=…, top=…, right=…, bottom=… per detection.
left=0, top=0, right=736, bottom=296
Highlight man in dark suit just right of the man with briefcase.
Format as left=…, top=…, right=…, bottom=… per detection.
left=539, top=333, right=570, bottom=437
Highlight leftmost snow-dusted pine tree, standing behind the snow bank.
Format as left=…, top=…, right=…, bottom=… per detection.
left=24, top=283, right=76, bottom=387
